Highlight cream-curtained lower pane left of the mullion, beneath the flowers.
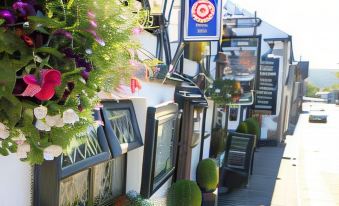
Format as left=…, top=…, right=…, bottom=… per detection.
left=59, top=170, right=89, bottom=206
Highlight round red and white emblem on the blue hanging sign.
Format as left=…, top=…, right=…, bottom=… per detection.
left=191, top=0, right=215, bottom=23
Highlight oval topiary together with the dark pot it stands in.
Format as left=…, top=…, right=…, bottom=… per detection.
left=197, top=159, right=219, bottom=206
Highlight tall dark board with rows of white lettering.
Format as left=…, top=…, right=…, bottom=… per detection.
left=254, top=57, right=279, bottom=115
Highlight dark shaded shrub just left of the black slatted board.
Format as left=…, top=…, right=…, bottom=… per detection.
left=210, top=128, right=227, bottom=158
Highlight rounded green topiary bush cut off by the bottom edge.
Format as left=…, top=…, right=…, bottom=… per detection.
left=167, top=180, right=202, bottom=206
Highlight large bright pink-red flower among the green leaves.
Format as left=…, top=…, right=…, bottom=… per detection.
left=21, top=69, right=61, bottom=101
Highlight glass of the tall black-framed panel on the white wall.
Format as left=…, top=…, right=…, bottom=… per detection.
left=153, top=119, right=175, bottom=187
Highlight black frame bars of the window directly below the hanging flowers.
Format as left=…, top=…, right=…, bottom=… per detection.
left=33, top=122, right=111, bottom=206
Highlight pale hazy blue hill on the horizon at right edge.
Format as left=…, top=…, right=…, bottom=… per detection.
left=308, top=69, right=339, bottom=88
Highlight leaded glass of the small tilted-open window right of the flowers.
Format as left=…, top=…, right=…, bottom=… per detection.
left=108, top=110, right=136, bottom=144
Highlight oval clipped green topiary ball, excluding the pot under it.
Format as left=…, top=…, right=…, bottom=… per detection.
left=197, top=159, right=219, bottom=192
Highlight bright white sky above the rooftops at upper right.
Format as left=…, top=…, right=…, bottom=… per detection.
left=231, top=0, right=339, bottom=69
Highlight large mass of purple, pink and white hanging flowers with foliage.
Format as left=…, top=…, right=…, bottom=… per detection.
left=0, top=0, right=145, bottom=164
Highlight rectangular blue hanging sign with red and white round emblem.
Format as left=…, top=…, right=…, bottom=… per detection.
left=184, top=0, right=222, bottom=41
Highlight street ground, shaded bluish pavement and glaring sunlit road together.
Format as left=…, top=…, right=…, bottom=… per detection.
left=218, top=103, right=339, bottom=206
